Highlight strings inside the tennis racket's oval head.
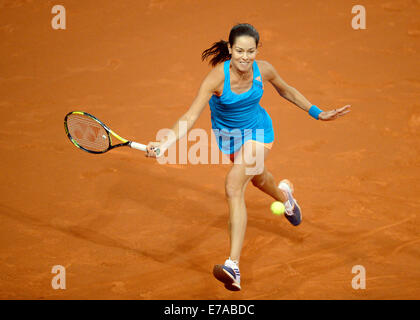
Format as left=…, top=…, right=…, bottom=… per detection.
left=67, top=114, right=110, bottom=152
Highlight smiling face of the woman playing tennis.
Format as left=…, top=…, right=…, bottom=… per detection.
left=229, top=36, right=257, bottom=72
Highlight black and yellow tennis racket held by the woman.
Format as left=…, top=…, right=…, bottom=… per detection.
left=64, top=111, right=160, bottom=156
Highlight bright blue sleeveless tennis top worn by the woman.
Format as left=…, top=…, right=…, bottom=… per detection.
left=209, top=60, right=274, bottom=154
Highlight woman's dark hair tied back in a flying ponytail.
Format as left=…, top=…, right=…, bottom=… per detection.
left=201, top=23, right=260, bottom=67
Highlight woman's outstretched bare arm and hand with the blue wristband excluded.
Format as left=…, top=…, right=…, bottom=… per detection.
left=259, top=61, right=350, bottom=121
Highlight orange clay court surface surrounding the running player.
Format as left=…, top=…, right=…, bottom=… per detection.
left=0, top=0, right=420, bottom=300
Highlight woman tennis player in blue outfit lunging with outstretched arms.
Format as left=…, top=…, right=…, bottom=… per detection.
left=146, top=24, right=350, bottom=291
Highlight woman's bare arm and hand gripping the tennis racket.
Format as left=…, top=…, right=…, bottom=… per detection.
left=146, top=65, right=224, bottom=157
